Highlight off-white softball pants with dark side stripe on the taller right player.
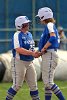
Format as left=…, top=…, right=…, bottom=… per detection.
left=41, top=50, right=58, bottom=86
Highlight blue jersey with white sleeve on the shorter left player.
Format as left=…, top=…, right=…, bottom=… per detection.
left=12, top=31, right=34, bottom=61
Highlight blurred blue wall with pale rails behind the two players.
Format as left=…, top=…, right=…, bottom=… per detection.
left=0, top=0, right=67, bottom=53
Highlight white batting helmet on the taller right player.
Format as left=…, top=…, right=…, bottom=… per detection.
left=36, top=7, right=53, bottom=21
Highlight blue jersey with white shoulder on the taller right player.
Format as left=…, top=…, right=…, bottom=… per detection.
left=39, top=22, right=60, bottom=51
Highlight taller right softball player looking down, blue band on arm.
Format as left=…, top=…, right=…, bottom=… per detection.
left=37, top=7, right=65, bottom=100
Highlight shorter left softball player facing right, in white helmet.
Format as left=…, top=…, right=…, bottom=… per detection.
left=6, top=16, right=40, bottom=100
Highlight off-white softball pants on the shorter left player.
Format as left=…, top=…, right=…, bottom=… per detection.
left=12, top=58, right=37, bottom=91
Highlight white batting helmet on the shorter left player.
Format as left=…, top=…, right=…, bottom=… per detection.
left=15, top=16, right=30, bottom=29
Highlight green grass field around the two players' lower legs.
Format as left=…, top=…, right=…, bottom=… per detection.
left=0, top=81, right=67, bottom=100
